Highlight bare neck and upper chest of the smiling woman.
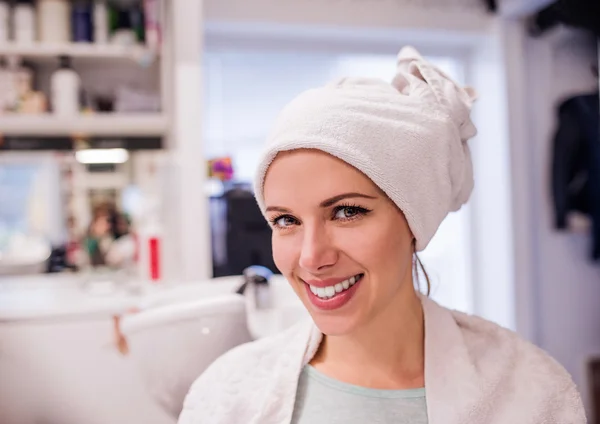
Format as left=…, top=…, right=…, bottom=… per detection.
left=311, top=284, right=424, bottom=389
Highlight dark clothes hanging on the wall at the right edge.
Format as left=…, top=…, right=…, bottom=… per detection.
left=552, top=93, right=600, bottom=260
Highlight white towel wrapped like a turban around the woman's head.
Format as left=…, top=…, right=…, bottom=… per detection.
left=255, top=47, right=476, bottom=250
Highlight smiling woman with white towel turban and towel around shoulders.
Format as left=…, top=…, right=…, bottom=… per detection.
left=180, top=48, right=585, bottom=424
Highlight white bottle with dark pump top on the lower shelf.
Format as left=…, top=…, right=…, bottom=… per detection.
left=50, top=56, right=81, bottom=116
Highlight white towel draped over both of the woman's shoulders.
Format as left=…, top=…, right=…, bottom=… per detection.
left=179, top=297, right=586, bottom=424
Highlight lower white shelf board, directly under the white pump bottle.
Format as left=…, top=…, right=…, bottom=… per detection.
left=0, top=113, right=168, bottom=137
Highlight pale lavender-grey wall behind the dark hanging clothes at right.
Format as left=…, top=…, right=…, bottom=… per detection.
left=524, top=30, right=600, bottom=410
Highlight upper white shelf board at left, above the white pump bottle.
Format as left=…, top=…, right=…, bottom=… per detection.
left=0, top=43, right=158, bottom=64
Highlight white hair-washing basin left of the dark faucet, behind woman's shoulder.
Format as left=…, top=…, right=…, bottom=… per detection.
left=121, top=294, right=251, bottom=418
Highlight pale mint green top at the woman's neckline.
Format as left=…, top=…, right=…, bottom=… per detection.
left=292, top=365, right=427, bottom=424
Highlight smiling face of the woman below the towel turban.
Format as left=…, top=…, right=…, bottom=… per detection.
left=264, top=150, right=413, bottom=336
